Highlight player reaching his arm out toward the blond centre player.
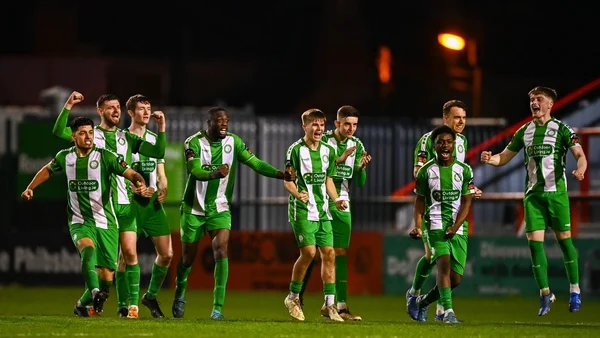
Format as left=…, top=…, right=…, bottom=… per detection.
left=172, top=107, right=295, bottom=320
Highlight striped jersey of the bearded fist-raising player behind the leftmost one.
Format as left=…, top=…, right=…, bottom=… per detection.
left=94, top=126, right=142, bottom=205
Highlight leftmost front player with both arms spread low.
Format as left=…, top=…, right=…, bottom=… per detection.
left=21, top=117, right=146, bottom=317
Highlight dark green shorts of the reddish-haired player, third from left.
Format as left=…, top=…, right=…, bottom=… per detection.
left=132, top=194, right=171, bottom=237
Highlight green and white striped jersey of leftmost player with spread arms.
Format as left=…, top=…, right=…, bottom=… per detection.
left=49, top=146, right=129, bottom=229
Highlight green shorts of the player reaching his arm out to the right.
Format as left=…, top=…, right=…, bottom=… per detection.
left=179, top=211, right=231, bottom=243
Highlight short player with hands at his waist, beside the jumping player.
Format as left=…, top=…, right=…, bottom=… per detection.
left=414, top=126, right=475, bottom=323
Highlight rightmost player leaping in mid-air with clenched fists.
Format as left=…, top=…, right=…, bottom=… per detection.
left=481, top=87, right=587, bottom=316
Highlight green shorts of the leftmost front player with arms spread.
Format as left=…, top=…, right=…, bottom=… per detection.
left=69, top=224, right=119, bottom=270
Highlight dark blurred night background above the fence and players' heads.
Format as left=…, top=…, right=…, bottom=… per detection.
left=0, top=0, right=600, bottom=121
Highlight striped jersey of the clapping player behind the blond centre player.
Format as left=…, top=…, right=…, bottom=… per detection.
left=321, top=130, right=365, bottom=212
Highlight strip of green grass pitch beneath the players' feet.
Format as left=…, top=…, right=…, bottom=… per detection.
left=0, top=286, right=600, bottom=338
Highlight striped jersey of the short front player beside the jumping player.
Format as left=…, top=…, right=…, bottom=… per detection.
left=416, top=159, right=475, bottom=235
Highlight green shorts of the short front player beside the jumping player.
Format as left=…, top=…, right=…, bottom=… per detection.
left=423, top=230, right=469, bottom=276
